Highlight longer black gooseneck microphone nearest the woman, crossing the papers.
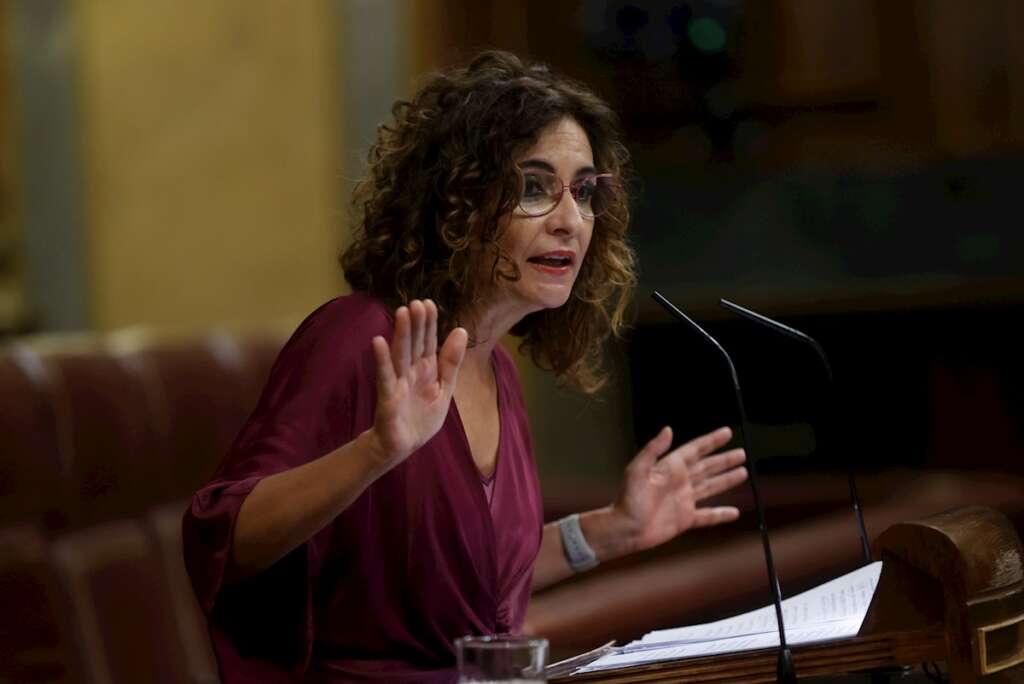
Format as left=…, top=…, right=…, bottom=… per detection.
left=651, top=290, right=797, bottom=684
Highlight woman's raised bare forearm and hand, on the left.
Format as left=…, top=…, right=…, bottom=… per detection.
left=228, top=301, right=469, bottom=580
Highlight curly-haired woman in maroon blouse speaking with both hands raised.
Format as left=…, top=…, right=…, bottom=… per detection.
left=184, top=52, right=746, bottom=684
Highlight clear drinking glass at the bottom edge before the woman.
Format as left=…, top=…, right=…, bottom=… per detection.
left=455, top=634, right=548, bottom=684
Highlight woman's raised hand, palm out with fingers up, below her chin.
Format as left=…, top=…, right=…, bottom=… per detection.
left=373, top=299, right=469, bottom=467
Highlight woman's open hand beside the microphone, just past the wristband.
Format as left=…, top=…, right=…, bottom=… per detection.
left=610, top=427, right=746, bottom=553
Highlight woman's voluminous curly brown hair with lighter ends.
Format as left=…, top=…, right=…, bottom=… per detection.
left=340, top=51, right=636, bottom=392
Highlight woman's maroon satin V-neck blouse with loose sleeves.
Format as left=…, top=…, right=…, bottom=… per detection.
left=183, top=294, right=543, bottom=684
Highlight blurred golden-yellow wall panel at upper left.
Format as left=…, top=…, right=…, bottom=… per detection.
left=74, top=0, right=344, bottom=330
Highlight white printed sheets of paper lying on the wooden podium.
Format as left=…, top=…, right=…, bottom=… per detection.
left=577, top=562, right=882, bottom=672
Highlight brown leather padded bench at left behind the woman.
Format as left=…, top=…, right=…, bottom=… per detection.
left=0, top=328, right=288, bottom=684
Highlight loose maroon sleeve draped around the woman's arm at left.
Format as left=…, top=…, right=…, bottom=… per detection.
left=182, top=295, right=392, bottom=684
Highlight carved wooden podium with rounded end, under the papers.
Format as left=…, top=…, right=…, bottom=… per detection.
left=550, top=506, right=1024, bottom=684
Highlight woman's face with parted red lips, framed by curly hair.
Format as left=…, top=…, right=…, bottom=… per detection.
left=491, top=119, right=595, bottom=315
